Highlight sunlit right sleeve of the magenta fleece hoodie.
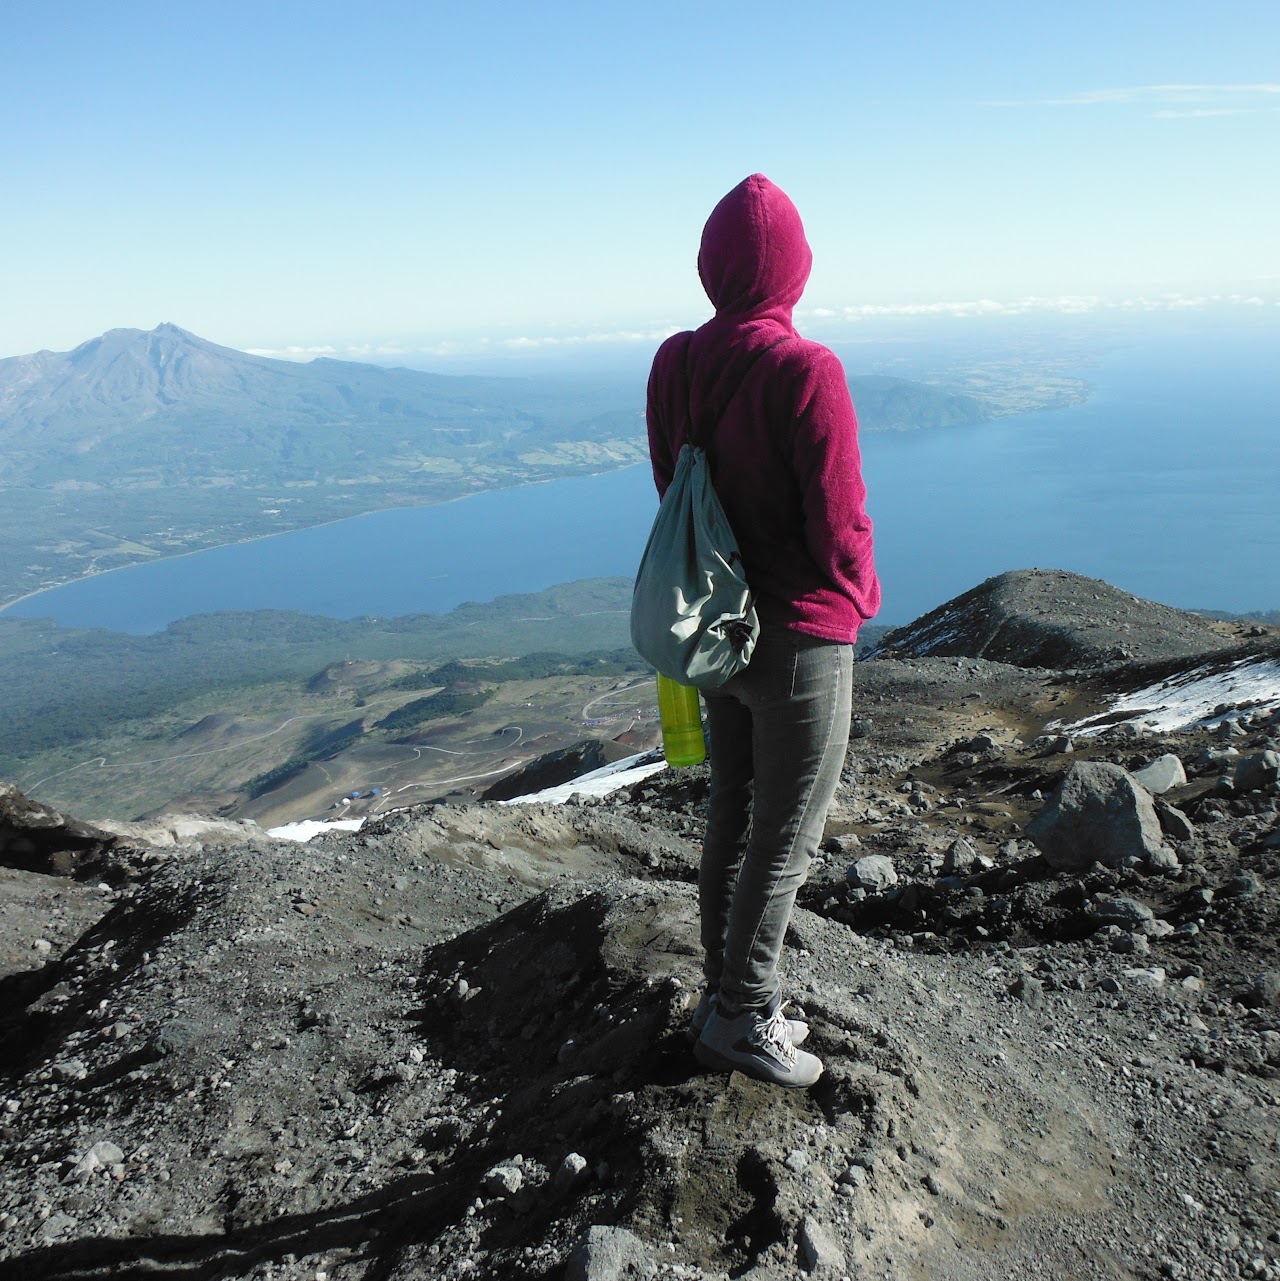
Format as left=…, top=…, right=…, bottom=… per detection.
left=792, top=350, right=880, bottom=619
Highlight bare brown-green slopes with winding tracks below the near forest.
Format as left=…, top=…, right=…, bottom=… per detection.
left=15, top=662, right=657, bottom=826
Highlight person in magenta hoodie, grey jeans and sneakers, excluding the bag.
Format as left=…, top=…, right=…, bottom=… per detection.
left=647, top=174, right=880, bottom=1086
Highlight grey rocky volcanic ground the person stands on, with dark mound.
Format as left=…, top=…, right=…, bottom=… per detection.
left=0, top=575, right=1280, bottom=1281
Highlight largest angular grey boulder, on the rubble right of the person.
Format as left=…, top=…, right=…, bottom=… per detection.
left=1026, top=761, right=1170, bottom=871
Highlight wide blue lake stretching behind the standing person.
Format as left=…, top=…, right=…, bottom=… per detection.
left=8, top=329, right=1280, bottom=632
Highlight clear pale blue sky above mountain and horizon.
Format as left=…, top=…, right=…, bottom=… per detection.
left=0, top=0, right=1280, bottom=363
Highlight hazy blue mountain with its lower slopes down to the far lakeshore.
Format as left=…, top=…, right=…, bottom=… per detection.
left=0, top=324, right=647, bottom=605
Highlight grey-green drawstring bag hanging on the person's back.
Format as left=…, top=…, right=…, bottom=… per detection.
left=632, top=343, right=776, bottom=689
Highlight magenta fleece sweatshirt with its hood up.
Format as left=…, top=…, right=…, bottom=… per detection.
left=647, top=173, right=880, bottom=643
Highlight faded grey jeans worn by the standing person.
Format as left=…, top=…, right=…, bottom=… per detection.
left=698, top=629, right=853, bottom=1009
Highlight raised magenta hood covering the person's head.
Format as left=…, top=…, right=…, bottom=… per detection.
left=698, top=173, right=814, bottom=324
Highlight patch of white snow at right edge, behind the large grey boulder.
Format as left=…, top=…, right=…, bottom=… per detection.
left=1066, top=657, right=1280, bottom=735
